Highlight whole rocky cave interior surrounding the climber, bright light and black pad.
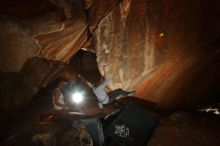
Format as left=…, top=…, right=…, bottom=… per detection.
left=0, top=0, right=220, bottom=146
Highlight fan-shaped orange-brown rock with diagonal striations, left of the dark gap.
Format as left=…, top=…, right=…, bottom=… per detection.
left=35, top=0, right=88, bottom=62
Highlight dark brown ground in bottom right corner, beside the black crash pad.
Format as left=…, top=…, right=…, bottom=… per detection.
left=148, top=111, right=220, bottom=146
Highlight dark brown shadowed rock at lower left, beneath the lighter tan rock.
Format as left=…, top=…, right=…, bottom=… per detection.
left=0, top=57, right=64, bottom=114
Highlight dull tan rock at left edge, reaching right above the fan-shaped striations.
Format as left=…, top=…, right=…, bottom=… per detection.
left=0, top=13, right=62, bottom=72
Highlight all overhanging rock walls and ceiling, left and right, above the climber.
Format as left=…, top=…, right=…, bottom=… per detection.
left=0, top=0, right=220, bottom=112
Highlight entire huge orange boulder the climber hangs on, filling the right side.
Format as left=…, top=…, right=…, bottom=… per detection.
left=95, top=0, right=220, bottom=108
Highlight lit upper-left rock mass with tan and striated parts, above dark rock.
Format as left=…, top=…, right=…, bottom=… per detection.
left=0, top=0, right=88, bottom=72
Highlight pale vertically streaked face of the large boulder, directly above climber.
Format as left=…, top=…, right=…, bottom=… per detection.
left=95, top=0, right=156, bottom=90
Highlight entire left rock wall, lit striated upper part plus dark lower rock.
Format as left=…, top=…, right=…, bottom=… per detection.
left=0, top=0, right=88, bottom=113
